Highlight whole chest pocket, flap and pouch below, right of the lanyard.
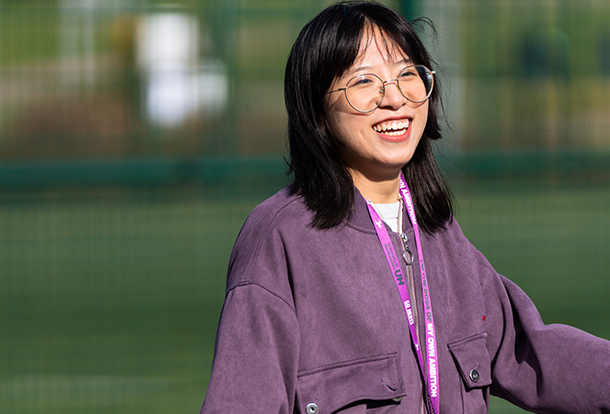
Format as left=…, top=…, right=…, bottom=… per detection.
left=447, top=333, right=491, bottom=413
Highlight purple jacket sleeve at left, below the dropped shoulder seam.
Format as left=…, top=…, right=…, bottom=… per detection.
left=201, top=284, right=299, bottom=414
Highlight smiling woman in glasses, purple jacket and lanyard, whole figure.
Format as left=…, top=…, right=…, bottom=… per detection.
left=202, top=2, right=610, bottom=414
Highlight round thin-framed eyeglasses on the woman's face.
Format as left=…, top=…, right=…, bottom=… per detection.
left=328, top=65, right=436, bottom=114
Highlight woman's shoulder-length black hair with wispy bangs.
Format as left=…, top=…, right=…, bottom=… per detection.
left=284, top=1, right=453, bottom=233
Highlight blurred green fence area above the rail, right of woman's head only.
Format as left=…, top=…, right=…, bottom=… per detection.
left=422, top=0, right=610, bottom=151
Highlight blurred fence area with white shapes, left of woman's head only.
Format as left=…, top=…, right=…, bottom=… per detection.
left=0, top=0, right=320, bottom=160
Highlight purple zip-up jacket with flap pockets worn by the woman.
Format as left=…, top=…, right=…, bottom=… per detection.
left=201, top=189, right=610, bottom=414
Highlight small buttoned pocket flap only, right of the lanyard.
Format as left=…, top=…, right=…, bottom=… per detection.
left=447, top=333, right=491, bottom=388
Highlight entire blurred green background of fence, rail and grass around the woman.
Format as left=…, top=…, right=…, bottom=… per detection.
left=0, top=0, right=610, bottom=414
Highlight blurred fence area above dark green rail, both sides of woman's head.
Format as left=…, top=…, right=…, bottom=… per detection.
left=0, top=0, right=610, bottom=183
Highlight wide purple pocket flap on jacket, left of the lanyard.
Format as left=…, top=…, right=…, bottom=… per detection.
left=297, top=354, right=406, bottom=414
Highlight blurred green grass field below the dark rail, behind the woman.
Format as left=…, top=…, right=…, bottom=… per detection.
left=0, top=175, right=610, bottom=414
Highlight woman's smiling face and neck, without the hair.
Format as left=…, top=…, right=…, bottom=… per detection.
left=327, top=30, right=429, bottom=203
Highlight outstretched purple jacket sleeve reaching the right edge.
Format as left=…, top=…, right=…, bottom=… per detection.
left=488, top=276, right=610, bottom=414
